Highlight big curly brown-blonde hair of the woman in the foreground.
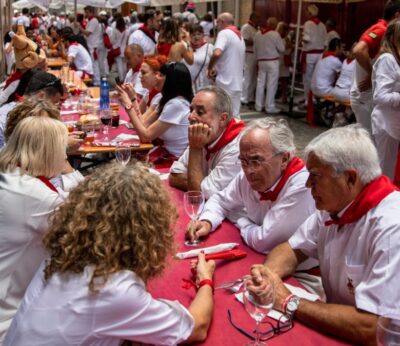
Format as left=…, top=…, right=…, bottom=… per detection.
left=43, top=163, right=177, bottom=293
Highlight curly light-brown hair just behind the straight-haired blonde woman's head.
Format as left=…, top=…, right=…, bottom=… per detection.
left=4, top=96, right=60, bottom=141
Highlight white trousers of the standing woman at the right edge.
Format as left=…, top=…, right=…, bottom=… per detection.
left=374, top=130, right=399, bottom=181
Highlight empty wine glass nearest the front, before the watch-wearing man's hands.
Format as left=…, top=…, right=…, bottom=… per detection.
left=243, top=276, right=275, bottom=346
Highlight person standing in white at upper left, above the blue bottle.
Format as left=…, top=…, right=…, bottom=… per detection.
left=79, top=6, right=103, bottom=86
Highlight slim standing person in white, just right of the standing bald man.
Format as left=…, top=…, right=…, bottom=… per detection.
left=240, top=12, right=260, bottom=104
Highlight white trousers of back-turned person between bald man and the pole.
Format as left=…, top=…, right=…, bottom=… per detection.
left=256, top=60, right=279, bottom=112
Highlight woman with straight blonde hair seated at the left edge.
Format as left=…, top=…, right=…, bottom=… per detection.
left=0, top=117, right=68, bottom=344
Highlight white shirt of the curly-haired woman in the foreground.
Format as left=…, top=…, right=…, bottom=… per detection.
left=4, top=263, right=194, bottom=346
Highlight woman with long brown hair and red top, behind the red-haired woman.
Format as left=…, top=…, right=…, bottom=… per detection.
left=157, top=19, right=193, bottom=65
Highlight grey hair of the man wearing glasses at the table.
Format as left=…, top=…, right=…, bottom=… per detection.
left=242, top=117, right=296, bottom=159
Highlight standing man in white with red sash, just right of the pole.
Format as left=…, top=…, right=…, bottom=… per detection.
left=301, top=4, right=326, bottom=105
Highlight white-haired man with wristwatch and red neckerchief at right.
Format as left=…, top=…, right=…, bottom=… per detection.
left=252, top=125, right=400, bottom=345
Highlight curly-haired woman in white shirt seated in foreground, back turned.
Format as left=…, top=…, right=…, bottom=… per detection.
left=4, top=163, right=215, bottom=345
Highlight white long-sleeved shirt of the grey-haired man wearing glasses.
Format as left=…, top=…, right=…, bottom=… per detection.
left=199, top=168, right=315, bottom=253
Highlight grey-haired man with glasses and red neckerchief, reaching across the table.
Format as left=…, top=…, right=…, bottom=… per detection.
left=187, top=117, right=315, bottom=253
